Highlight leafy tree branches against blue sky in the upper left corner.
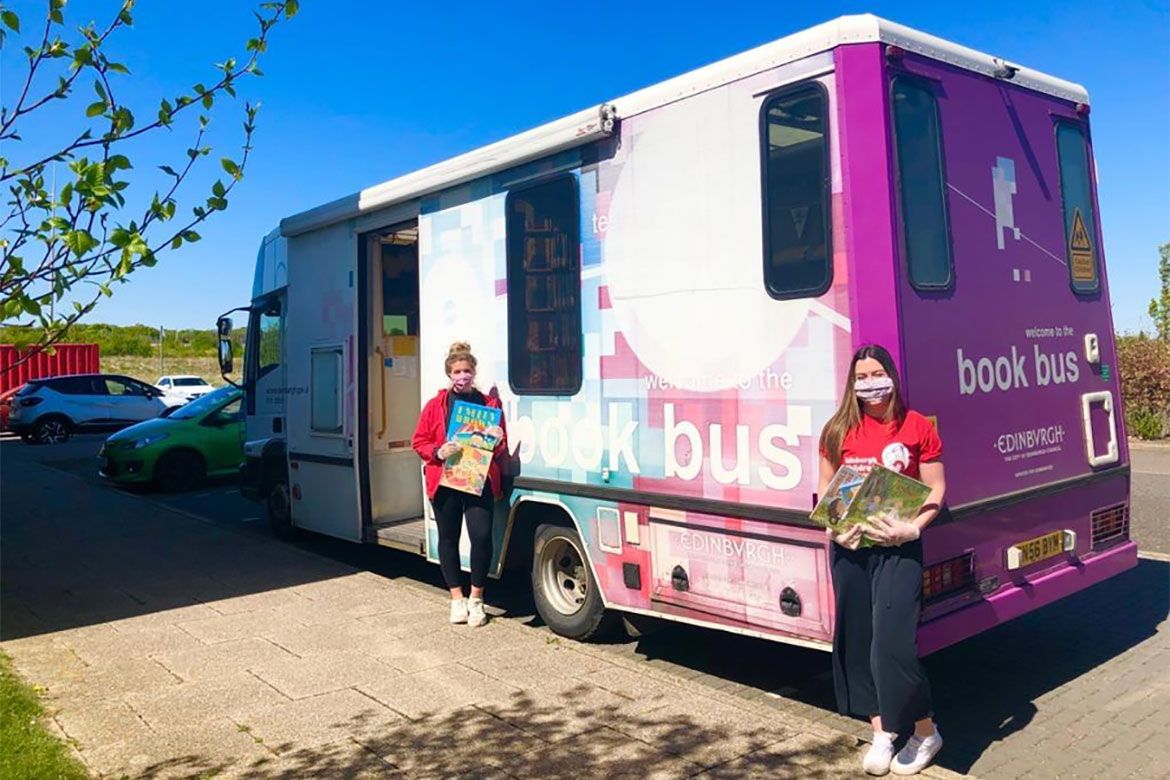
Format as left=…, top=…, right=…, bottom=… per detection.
left=0, top=0, right=298, bottom=369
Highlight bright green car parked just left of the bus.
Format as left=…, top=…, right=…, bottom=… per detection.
left=97, top=386, right=243, bottom=491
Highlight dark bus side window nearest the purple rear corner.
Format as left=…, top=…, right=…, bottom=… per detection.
left=761, top=83, right=833, bottom=298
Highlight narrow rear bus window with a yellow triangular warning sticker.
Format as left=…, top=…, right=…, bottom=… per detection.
left=1057, top=122, right=1101, bottom=292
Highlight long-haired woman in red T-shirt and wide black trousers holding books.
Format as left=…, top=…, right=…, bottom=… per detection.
left=819, top=345, right=947, bottom=775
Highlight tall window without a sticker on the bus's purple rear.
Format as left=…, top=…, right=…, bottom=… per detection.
left=892, top=76, right=954, bottom=289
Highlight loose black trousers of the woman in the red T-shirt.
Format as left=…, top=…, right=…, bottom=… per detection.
left=832, top=540, right=932, bottom=734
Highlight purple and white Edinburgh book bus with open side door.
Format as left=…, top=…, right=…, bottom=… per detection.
left=220, top=15, right=1137, bottom=654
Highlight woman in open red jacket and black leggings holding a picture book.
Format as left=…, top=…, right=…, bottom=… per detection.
left=411, top=341, right=508, bottom=626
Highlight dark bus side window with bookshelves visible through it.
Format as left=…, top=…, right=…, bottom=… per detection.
left=504, top=177, right=583, bottom=395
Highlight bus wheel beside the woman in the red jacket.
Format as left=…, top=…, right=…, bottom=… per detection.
left=532, top=525, right=618, bottom=640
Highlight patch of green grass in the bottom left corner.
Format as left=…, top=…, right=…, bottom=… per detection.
left=0, top=653, right=89, bottom=780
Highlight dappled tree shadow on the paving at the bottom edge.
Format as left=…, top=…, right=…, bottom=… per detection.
left=125, top=684, right=856, bottom=780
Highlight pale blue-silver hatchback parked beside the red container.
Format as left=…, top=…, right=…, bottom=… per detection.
left=8, top=374, right=167, bottom=444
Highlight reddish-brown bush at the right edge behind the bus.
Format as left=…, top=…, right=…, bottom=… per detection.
left=1117, top=334, right=1170, bottom=439
